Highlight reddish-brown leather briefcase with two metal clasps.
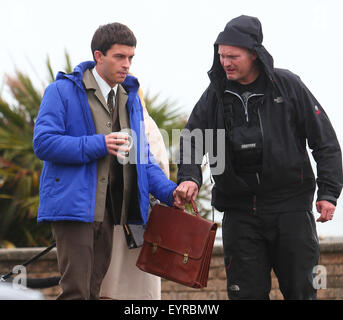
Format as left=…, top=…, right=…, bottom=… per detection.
left=136, top=204, right=217, bottom=288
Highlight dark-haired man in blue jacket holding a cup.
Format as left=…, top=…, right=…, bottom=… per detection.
left=33, top=23, right=176, bottom=299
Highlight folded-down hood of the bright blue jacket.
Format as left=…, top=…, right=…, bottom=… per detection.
left=56, top=61, right=139, bottom=93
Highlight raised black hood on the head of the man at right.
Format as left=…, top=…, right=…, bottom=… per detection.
left=209, top=15, right=274, bottom=85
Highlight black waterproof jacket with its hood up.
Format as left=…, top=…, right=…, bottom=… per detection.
left=178, top=16, right=343, bottom=212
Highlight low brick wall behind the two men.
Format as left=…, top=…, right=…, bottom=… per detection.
left=0, top=239, right=343, bottom=300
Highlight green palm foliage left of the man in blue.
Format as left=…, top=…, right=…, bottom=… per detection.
left=0, top=53, right=72, bottom=247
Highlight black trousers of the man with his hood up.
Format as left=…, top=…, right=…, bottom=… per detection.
left=223, top=211, right=319, bottom=300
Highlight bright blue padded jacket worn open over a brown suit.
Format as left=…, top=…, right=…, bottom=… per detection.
left=33, top=61, right=176, bottom=223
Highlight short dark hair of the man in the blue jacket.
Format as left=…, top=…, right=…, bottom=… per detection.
left=91, top=22, right=137, bottom=61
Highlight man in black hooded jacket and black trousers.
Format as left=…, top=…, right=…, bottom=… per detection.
left=175, top=16, right=343, bottom=299
